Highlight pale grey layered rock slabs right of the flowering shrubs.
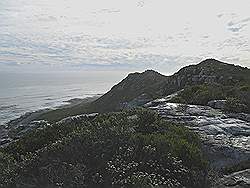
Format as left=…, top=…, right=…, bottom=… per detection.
left=145, top=97, right=250, bottom=187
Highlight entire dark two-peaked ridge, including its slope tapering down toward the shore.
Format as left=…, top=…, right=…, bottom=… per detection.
left=36, top=59, right=250, bottom=121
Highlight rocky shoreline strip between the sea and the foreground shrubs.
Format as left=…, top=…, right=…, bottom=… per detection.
left=0, top=94, right=102, bottom=145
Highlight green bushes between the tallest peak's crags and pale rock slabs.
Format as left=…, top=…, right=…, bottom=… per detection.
left=172, top=84, right=250, bottom=113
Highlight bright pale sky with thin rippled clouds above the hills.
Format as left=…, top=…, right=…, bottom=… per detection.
left=0, top=0, right=250, bottom=74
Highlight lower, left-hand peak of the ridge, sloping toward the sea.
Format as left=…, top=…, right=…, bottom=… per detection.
left=92, top=70, right=167, bottom=112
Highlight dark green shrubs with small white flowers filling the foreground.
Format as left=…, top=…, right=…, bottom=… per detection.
left=0, top=109, right=207, bottom=187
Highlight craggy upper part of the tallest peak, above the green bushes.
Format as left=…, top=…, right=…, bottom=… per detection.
left=165, top=59, right=250, bottom=93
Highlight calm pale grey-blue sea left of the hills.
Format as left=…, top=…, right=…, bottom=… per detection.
left=0, top=71, right=125, bottom=125
